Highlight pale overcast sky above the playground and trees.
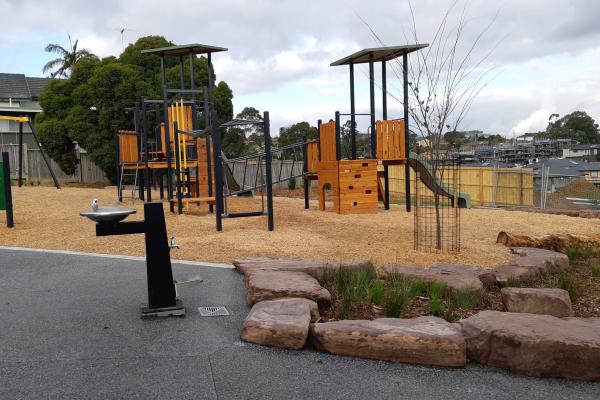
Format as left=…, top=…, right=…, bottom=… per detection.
left=0, top=0, right=600, bottom=137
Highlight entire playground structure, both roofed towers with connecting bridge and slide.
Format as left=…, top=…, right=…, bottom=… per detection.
left=117, top=44, right=470, bottom=230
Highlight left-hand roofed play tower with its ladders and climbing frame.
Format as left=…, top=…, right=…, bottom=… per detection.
left=116, top=44, right=308, bottom=231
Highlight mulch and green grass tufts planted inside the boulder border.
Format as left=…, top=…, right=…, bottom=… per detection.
left=319, top=247, right=600, bottom=322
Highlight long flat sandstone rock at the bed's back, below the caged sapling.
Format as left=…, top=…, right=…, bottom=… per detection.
left=383, top=264, right=488, bottom=291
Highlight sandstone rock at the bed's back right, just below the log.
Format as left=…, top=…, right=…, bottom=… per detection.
left=492, top=247, right=569, bottom=283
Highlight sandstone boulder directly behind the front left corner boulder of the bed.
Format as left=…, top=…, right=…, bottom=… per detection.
left=246, top=270, right=331, bottom=305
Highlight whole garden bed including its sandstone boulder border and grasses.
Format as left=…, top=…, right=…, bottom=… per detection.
left=233, top=241, right=600, bottom=381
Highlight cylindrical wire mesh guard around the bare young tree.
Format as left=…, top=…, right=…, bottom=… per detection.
left=414, top=154, right=460, bottom=253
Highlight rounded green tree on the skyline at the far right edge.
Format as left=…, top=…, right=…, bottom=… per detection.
left=540, top=111, right=600, bottom=144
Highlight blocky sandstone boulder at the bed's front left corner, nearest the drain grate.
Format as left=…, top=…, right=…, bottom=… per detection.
left=242, top=299, right=316, bottom=350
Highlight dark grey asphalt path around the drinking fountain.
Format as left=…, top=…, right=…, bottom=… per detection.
left=0, top=249, right=600, bottom=400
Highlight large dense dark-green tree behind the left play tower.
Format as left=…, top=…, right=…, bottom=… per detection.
left=37, top=36, right=233, bottom=181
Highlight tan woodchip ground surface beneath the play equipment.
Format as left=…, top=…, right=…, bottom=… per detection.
left=0, top=187, right=600, bottom=268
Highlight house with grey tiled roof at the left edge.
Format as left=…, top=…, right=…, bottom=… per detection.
left=0, top=73, right=51, bottom=145
